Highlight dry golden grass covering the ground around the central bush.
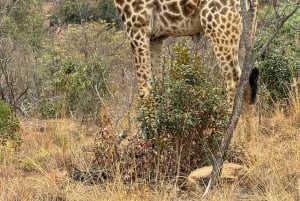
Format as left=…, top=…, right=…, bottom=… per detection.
left=0, top=106, right=300, bottom=201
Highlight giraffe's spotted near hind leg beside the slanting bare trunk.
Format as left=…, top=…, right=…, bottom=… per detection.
left=201, top=4, right=242, bottom=110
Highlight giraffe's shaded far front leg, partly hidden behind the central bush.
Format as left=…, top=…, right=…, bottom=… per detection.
left=150, top=38, right=163, bottom=77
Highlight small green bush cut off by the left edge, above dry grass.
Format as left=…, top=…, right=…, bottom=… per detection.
left=0, top=100, right=21, bottom=145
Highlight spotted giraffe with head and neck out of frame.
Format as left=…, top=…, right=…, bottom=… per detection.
left=114, top=0, right=258, bottom=108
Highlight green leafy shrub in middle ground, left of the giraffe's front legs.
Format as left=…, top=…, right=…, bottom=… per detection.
left=48, top=58, right=108, bottom=121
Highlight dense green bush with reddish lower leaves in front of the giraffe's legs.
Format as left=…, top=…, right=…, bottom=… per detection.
left=138, top=45, right=228, bottom=168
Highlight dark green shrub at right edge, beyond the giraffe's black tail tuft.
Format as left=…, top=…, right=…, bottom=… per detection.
left=256, top=2, right=300, bottom=106
